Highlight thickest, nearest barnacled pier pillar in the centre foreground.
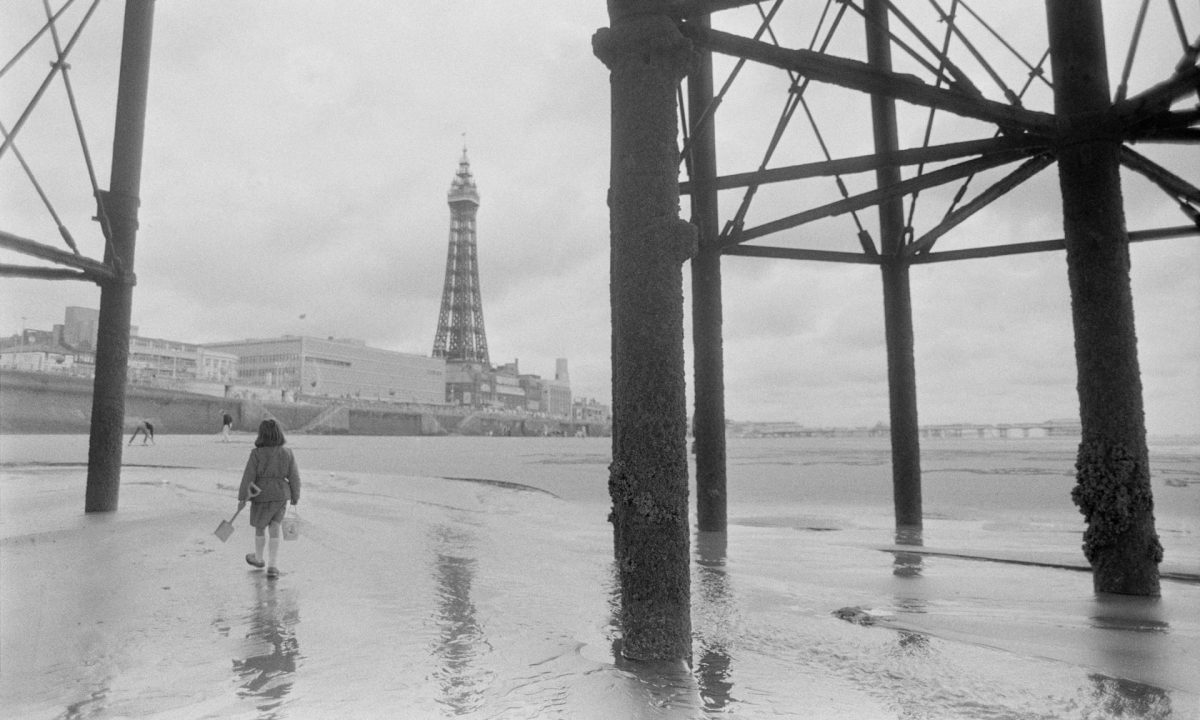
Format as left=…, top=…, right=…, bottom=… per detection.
left=592, top=0, right=696, bottom=660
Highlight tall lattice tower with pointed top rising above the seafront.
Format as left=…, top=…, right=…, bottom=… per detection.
left=433, top=148, right=491, bottom=367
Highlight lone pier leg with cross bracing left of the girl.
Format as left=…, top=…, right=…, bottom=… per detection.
left=0, top=0, right=154, bottom=512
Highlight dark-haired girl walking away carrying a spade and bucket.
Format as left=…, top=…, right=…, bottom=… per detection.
left=235, top=415, right=300, bottom=577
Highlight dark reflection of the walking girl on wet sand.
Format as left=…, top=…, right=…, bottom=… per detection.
left=233, top=583, right=300, bottom=720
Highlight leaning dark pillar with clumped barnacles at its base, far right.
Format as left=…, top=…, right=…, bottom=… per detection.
left=1046, top=0, right=1163, bottom=595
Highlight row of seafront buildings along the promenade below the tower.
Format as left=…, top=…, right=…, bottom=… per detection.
left=0, top=301, right=590, bottom=422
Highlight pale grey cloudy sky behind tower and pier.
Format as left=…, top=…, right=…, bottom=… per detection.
left=0, top=0, right=1200, bottom=433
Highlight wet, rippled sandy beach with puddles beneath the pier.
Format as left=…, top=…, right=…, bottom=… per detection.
left=0, top=433, right=1200, bottom=720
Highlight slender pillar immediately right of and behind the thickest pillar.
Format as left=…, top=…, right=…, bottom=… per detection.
left=688, top=16, right=727, bottom=532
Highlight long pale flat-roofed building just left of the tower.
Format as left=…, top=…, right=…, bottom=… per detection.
left=204, top=335, right=446, bottom=404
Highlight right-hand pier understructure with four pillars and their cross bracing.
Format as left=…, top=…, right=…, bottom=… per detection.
left=593, top=0, right=1200, bottom=659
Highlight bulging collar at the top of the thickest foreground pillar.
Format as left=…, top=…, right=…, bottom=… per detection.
left=592, top=14, right=700, bottom=83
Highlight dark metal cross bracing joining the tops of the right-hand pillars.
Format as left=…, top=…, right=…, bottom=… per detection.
left=680, top=0, right=1200, bottom=265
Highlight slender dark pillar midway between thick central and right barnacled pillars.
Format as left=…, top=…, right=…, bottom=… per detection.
left=864, top=0, right=923, bottom=529
